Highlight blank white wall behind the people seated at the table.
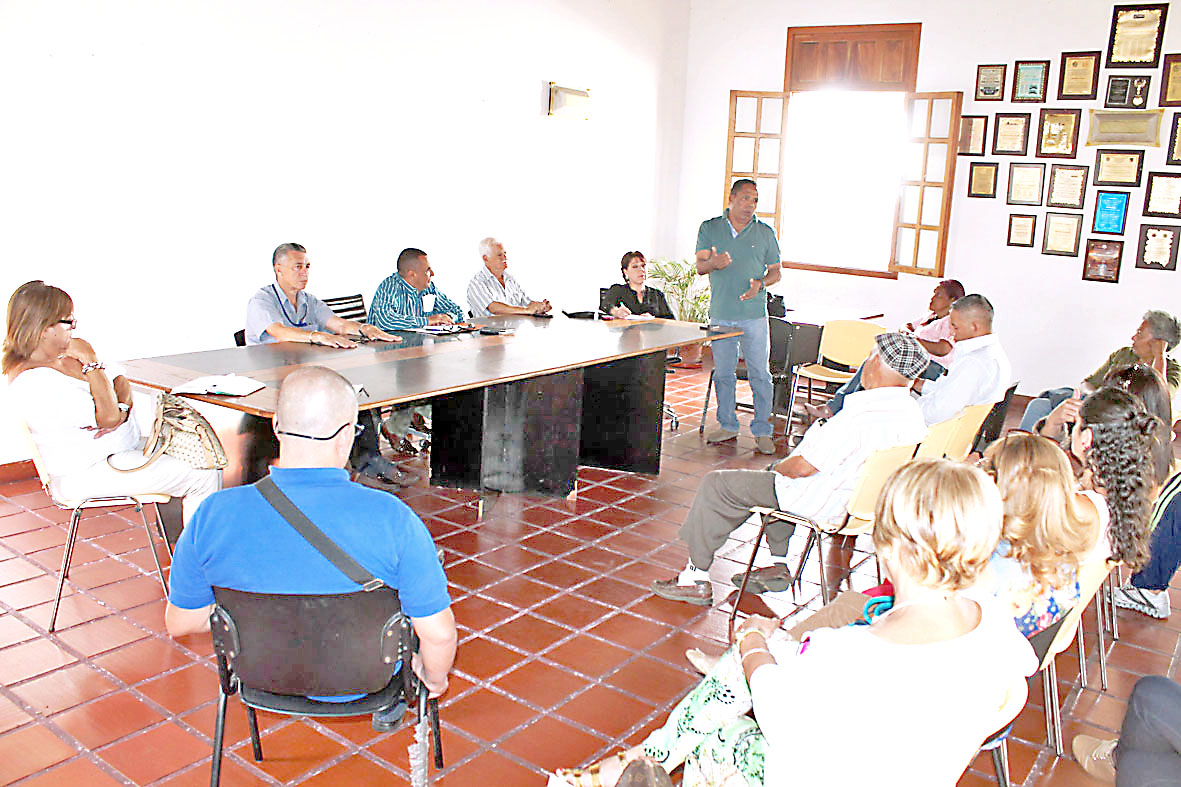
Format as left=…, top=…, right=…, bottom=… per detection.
left=0, top=0, right=689, bottom=462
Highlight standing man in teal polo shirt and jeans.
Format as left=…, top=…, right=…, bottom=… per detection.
left=697, top=178, right=779, bottom=454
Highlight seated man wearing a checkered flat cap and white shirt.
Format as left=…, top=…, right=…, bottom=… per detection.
left=652, top=333, right=931, bottom=605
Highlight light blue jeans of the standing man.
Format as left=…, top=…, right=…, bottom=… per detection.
left=711, top=317, right=774, bottom=437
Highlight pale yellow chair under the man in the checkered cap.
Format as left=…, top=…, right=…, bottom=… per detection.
left=730, top=443, right=918, bottom=640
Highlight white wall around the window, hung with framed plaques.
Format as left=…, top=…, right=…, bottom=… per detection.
left=677, top=0, right=1181, bottom=394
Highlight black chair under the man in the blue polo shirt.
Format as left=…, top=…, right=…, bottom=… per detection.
left=209, top=587, right=443, bottom=787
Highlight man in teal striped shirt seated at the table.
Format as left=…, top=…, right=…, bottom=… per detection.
left=368, top=248, right=463, bottom=331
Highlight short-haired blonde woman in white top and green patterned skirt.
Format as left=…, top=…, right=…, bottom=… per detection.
left=549, top=460, right=1037, bottom=787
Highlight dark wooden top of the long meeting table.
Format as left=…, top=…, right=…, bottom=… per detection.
left=124, top=316, right=740, bottom=417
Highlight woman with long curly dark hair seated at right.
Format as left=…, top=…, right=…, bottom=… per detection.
left=1070, top=386, right=1161, bottom=571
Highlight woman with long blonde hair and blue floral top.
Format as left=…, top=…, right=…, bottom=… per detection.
left=981, top=432, right=1111, bottom=637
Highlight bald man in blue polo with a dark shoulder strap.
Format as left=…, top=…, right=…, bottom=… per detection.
left=164, top=366, right=456, bottom=731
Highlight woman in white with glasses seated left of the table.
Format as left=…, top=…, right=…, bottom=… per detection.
left=2, top=280, right=221, bottom=522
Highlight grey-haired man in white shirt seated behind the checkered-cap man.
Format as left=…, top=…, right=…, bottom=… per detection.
left=915, top=294, right=1012, bottom=425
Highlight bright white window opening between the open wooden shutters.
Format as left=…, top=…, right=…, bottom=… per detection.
left=784, top=90, right=902, bottom=271
